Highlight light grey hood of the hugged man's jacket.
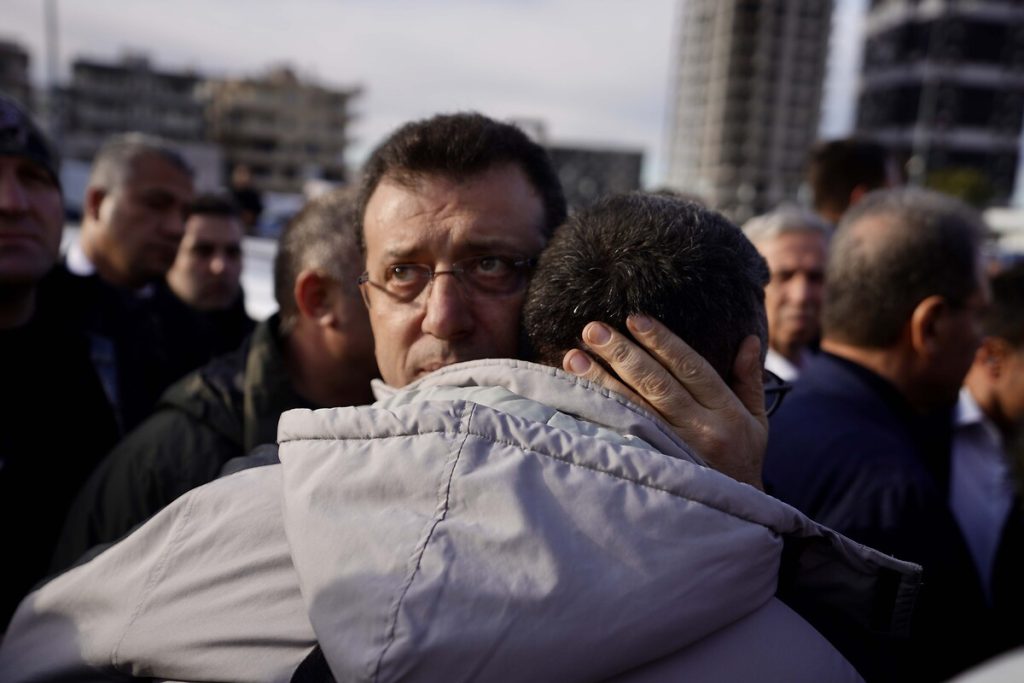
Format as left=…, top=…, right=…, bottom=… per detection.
left=279, top=360, right=915, bottom=681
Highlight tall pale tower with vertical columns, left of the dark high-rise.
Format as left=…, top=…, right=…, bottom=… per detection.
left=666, top=0, right=833, bottom=221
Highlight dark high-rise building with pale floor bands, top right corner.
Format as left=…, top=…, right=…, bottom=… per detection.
left=857, top=0, right=1024, bottom=205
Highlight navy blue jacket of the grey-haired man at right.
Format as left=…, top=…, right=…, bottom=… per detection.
left=764, top=353, right=998, bottom=681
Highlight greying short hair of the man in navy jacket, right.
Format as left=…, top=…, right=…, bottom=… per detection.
left=821, top=188, right=985, bottom=348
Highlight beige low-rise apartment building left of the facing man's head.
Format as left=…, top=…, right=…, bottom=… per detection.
left=202, top=68, right=359, bottom=193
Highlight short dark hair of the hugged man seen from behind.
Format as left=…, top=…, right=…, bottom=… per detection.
left=523, top=193, right=768, bottom=380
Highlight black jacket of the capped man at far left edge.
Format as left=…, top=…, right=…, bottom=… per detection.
left=0, top=274, right=118, bottom=633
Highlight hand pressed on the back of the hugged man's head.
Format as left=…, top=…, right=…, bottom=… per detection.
left=562, top=315, right=768, bottom=488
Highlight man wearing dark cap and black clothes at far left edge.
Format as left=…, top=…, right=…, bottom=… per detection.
left=0, top=95, right=116, bottom=632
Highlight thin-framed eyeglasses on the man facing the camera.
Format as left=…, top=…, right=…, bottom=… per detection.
left=356, top=255, right=537, bottom=303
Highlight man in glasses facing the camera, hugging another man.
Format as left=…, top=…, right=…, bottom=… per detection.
left=356, top=114, right=766, bottom=486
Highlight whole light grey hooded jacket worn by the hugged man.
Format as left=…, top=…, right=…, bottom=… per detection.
left=0, top=360, right=918, bottom=681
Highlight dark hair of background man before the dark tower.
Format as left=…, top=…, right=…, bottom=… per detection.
left=807, top=138, right=889, bottom=214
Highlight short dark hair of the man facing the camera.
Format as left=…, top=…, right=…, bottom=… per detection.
left=356, top=113, right=566, bottom=249
